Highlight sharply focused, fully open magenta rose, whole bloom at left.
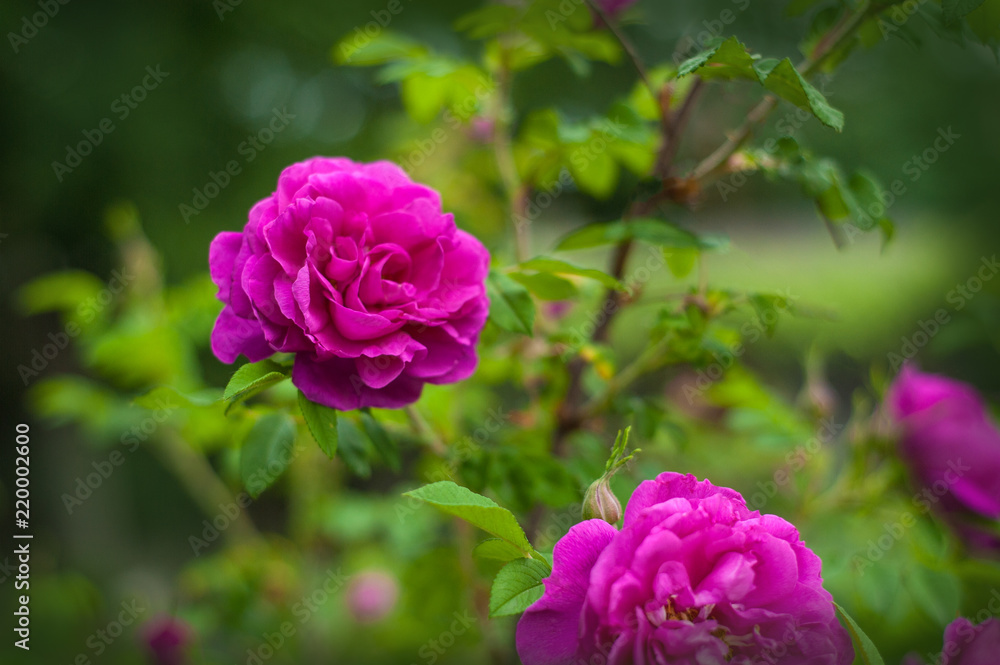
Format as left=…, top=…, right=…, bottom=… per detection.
left=209, top=157, right=489, bottom=410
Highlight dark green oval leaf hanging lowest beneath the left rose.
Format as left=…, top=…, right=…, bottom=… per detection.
left=240, top=413, right=295, bottom=499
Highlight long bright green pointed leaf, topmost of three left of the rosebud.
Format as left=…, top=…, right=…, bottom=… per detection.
left=405, top=480, right=535, bottom=556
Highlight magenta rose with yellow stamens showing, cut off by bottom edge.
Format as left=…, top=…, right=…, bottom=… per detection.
left=517, top=473, right=854, bottom=665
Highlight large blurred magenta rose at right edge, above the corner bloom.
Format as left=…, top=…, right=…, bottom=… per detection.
left=886, top=365, right=1000, bottom=519
